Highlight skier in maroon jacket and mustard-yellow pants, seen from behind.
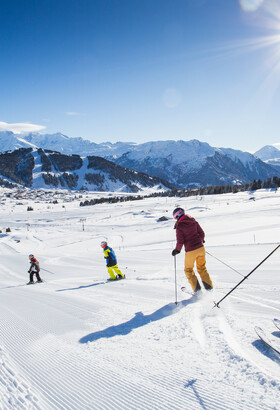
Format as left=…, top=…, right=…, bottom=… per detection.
left=172, top=208, right=213, bottom=292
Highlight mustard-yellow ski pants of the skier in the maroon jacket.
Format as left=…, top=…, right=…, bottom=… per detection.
left=185, top=246, right=213, bottom=291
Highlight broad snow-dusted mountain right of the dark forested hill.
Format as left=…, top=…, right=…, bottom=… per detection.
left=107, top=140, right=279, bottom=188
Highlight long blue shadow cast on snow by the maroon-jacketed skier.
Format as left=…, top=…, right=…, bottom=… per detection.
left=79, top=297, right=196, bottom=343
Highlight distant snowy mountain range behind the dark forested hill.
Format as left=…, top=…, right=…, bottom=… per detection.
left=0, top=132, right=280, bottom=188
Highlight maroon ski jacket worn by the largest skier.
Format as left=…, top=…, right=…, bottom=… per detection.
left=174, top=215, right=205, bottom=252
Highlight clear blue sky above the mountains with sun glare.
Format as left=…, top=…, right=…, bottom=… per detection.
left=0, top=0, right=280, bottom=152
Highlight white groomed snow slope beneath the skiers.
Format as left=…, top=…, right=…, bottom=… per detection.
left=0, top=190, right=280, bottom=410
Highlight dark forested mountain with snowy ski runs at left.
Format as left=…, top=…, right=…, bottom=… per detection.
left=0, top=148, right=172, bottom=192
